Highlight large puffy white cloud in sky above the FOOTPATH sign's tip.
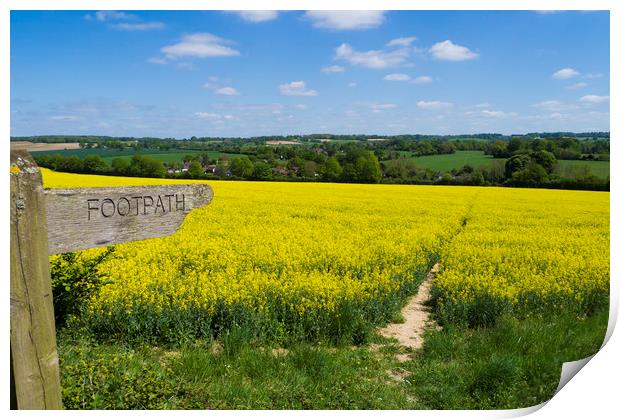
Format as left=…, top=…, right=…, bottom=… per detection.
left=161, top=33, right=239, bottom=59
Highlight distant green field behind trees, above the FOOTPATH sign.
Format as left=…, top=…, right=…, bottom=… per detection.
left=32, top=149, right=245, bottom=165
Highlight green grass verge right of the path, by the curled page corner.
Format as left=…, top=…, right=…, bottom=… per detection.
left=405, top=310, right=607, bottom=409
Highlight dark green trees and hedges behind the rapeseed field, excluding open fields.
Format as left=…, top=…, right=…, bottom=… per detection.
left=36, top=137, right=609, bottom=190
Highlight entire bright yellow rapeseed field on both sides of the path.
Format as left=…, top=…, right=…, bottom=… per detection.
left=43, top=169, right=609, bottom=337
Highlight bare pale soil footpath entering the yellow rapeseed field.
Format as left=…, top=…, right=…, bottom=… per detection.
left=379, top=264, right=439, bottom=350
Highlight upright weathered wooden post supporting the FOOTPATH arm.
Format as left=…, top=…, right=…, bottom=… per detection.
left=10, top=151, right=62, bottom=409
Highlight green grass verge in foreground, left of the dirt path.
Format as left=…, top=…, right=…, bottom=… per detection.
left=59, top=331, right=409, bottom=409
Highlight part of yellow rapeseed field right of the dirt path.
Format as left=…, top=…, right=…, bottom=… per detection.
left=435, top=188, right=609, bottom=324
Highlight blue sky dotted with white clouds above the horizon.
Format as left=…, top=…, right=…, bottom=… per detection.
left=11, top=11, right=610, bottom=138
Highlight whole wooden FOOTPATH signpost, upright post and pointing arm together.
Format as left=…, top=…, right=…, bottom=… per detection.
left=11, top=150, right=213, bottom=409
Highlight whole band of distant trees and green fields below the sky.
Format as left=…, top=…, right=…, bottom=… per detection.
left=30, top=133, right=610, bottom=190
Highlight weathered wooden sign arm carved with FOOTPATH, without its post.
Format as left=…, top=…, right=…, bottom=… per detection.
left=45, top=184, right=213, bottom=254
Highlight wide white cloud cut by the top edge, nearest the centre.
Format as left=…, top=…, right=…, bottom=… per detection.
left=304, top=10, right=385, bottom=31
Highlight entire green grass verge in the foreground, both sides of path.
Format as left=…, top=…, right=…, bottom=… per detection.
left=58, top=311, right=607, bottom=409
